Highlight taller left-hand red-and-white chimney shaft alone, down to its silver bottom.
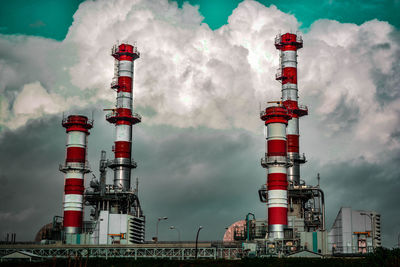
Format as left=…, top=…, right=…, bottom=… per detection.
left=106, top=44, right=141, bottom=191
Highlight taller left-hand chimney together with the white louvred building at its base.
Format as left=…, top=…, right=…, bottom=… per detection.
left=85, top=43, right=145, bottom=244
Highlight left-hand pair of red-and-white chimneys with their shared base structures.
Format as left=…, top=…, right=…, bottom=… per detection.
left=59, top=44, right=145, bottom=245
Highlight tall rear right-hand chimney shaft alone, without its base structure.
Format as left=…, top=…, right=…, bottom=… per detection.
left=275, top=33, right=308, bottom=185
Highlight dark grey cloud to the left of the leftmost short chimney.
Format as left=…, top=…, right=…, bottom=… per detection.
left=0, top=117, right=65, bottom=240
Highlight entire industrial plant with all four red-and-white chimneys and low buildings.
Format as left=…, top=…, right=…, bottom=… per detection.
left=0, top=33, right=381, bottom=259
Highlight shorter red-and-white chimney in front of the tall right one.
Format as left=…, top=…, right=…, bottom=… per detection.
left=261, top=104, right=291, bottom=240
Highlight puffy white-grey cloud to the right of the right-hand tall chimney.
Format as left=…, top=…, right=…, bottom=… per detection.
left=300, top=20, right=400, bottom=162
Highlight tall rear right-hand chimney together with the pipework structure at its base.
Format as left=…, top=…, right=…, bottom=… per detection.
left=275, top=33, right=325, bottom=231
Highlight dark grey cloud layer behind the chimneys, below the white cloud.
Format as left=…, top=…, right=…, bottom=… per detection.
left=0, top=111, right=400, bottom=246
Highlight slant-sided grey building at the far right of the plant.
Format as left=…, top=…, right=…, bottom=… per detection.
left=328, top=207, right=381, bottom=254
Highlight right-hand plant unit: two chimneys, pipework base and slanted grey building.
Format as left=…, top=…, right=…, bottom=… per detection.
left=224, top=33, right=381, bottom=256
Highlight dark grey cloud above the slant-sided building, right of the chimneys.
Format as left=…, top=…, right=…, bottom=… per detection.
left=305, top=155, right=400, bottom=247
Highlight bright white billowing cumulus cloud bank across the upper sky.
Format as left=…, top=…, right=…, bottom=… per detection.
left=0, top=0, right=400, bottom=164
